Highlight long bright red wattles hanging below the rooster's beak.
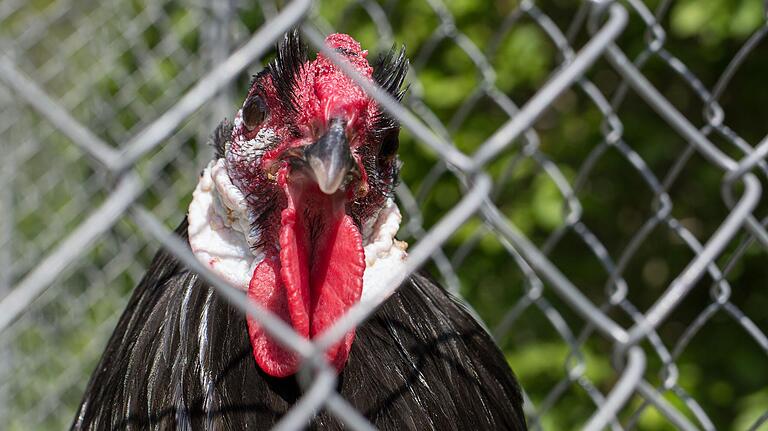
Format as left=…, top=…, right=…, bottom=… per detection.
left=248, top=170, right=365, bottom=377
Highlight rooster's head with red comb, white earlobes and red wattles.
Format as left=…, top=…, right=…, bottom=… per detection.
left=188, top=31, right=408, bottom=377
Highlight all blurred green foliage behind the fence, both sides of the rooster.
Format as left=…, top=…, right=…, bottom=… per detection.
left=1, top=0, right=768, bottom=430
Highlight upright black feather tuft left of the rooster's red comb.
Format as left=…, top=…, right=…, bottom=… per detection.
left=267, top=29, right=307, bottom=112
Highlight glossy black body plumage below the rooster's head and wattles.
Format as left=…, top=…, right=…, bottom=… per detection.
left=73, top=222, right=525, bottom=430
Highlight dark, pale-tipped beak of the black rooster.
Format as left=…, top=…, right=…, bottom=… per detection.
left=304, top=118, right=355, bottom=195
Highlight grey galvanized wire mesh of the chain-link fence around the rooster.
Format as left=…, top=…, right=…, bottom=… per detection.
left=0, top=0, right=768, bottom=430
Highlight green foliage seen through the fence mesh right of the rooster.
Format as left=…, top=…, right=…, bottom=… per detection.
left=321, top=0, right=768, bottom=430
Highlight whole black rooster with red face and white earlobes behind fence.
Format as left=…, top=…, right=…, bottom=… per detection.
left=73, top=31, right=526, bottom=430
